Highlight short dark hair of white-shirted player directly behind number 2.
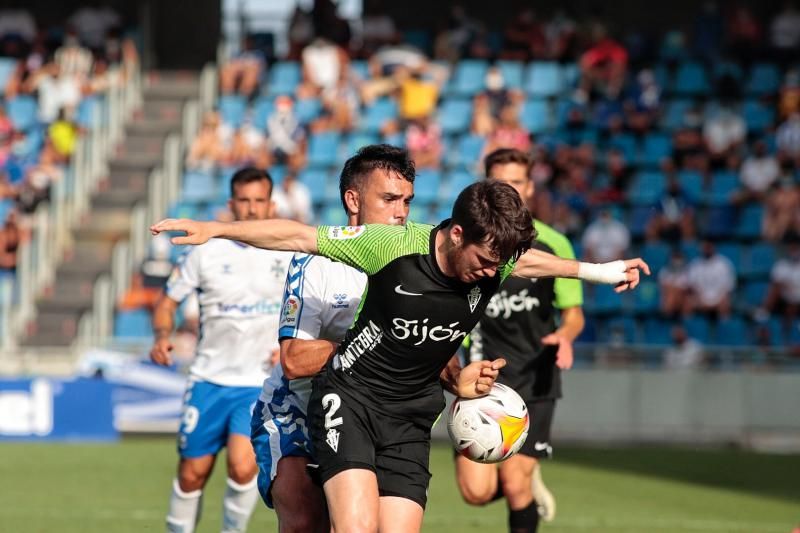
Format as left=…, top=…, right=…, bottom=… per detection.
left=339, top=144, right=417, bottom=211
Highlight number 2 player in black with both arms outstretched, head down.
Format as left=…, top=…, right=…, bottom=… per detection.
left=150, top=181, right=649, bottom=533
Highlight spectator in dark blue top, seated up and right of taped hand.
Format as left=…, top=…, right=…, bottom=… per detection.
left=645, top=173, right=695, bottom=243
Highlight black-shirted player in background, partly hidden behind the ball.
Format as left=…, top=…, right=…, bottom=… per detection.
left=456, top=148, right=584, bottom=533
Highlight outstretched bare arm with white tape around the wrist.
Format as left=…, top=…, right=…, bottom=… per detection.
left=512, top=249, right=650, bottom=292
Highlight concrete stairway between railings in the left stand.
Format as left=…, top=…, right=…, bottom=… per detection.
left=21, top=72, right=199, bottom=346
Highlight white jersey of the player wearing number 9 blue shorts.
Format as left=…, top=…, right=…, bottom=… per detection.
left=166, top=239, right=292, bottom=387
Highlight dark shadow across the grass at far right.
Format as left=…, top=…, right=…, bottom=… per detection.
left=556, top=446, right=800, bottom=503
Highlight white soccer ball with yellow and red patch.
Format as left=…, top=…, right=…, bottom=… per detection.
left=447, top=383, right=529, bottom=463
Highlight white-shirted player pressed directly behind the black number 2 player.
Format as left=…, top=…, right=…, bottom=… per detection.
left=252, top=145, right=415, bottom=533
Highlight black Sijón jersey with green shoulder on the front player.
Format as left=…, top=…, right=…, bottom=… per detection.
left=317, top=221, right=514, bottom=423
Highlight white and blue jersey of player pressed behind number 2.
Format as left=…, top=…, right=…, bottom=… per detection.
left=261, top=254, right=367, bottom=415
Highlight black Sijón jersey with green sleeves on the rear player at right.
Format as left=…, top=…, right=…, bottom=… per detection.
left=469, top=221, right=583, bottom=400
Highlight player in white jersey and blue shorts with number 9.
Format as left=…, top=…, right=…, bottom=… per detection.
left=150, top=168, right=292, bottom=533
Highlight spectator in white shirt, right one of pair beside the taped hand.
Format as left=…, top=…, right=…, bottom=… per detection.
left=684, top=240, right=736, bottom=318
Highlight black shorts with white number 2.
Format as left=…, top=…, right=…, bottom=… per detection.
left=308, top=372, right=431, bottom=509
